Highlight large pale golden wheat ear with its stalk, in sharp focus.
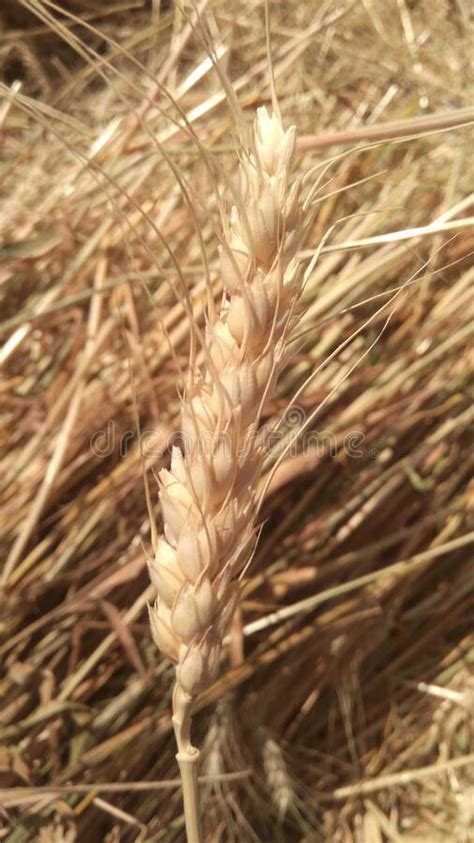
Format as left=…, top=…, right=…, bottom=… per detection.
left=150, top=108, right=302, bottom=843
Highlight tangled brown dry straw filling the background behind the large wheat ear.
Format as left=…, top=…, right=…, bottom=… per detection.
left=0, top=0, right=474, bottom=843
